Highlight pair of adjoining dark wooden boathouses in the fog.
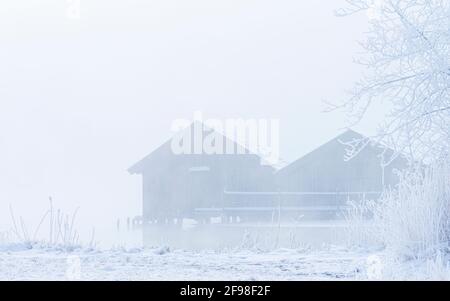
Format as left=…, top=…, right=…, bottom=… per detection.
left=130, top=129, right=406, bottom=223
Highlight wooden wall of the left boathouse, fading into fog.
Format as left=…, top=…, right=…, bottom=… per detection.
left=129, top=122, right=275, bottom=222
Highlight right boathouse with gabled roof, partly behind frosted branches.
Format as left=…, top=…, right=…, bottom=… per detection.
left=276, top=130, right=407, bottom=201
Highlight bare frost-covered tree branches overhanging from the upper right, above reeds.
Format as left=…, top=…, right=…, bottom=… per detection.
left=338, top=0, right=450, bottom=160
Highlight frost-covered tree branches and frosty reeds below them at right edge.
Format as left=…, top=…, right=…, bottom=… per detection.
left=339, top=0, right=450, bottom=269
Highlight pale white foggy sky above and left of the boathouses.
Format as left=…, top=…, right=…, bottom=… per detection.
left=0, top=0, right=384, bottom=234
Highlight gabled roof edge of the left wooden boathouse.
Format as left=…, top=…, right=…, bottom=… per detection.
left=128, top=121, right=272, bottom=174
